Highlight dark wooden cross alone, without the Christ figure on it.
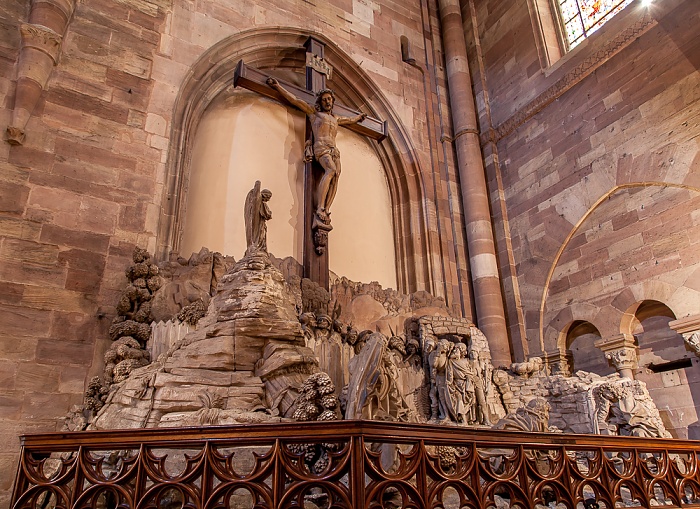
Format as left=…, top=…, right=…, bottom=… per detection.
left=233, top=37, right=387, bottom=290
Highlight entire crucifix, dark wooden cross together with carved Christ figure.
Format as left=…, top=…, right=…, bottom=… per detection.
left=233, top=37, right=386, bottom=289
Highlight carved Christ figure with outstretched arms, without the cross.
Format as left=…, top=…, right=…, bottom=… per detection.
left=267, top=78, right=367, bottom=224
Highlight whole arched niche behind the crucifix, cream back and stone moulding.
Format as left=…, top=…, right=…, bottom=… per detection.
left=158, top=28, right=434, bottom=293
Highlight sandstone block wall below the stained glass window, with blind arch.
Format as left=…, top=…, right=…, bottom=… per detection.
left=464, top=0, right=700, bottom=436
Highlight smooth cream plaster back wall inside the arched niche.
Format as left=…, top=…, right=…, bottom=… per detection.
left=180, top=90, right=396, bottom=288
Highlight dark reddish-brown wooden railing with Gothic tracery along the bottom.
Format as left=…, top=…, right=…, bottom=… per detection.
left=12, top=421, right=700, bottom=509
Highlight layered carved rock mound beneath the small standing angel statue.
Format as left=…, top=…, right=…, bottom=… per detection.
left=90, top=258, right=318, bottom=429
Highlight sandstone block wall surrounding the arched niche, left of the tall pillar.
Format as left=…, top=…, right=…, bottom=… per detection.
left=0, top=0, right=471, bottom=500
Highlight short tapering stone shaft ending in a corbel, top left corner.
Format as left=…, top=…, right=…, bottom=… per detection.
left=6, top=0, right=75, bottom=145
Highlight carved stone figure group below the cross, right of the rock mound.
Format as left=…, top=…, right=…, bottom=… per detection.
left=299, top=320, right=493, bottom=426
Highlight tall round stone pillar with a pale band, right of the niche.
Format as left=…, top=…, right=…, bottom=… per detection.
left=438, top=0, right=512, bottom=366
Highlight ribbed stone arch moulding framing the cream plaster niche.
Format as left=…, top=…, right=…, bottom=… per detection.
left=157, top=28, right=440, bottom=295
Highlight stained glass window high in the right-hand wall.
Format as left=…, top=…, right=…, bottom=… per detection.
left=559, top=0, right=633, bottom=48
